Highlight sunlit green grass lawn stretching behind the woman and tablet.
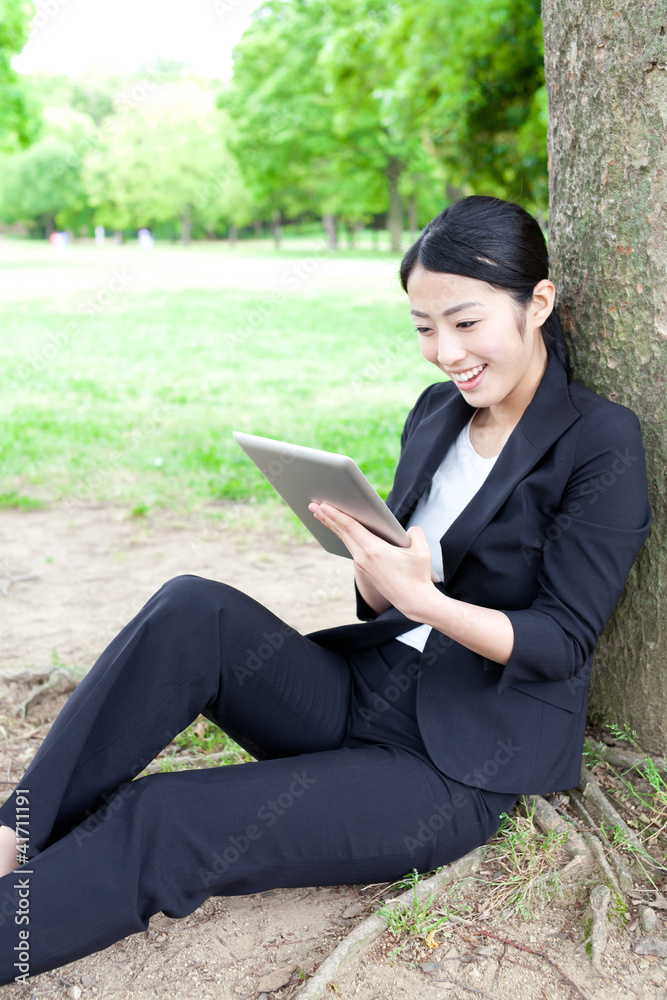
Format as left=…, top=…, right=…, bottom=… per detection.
left=0, top=246, right=446, bottom=536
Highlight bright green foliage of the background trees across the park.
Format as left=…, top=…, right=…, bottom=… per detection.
left=0, top=0, right=547, bottom=234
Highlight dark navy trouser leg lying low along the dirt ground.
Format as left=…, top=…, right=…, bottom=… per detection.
left=0, top=746, right=512, bottom=983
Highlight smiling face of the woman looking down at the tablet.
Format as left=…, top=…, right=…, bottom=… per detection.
left=408, top=265, right=554, bottom=407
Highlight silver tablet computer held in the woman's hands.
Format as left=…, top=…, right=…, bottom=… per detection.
left=232, top=431, right=410, bottom=559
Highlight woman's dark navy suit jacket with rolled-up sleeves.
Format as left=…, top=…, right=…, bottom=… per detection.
left=309, top=355, right=652, bottom=794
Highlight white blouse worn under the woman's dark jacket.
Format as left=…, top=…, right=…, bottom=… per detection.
left=396, top=413, right=498, bottom=650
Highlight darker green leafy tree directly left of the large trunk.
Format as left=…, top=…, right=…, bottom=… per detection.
left=385, top=0, right=547, bottom=210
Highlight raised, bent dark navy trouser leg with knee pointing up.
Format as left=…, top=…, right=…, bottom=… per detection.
left=0, top=576, right=350, bottom=857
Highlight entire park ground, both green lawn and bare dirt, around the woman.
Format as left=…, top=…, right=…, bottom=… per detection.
left=0, top=243, right=667, bottom=1000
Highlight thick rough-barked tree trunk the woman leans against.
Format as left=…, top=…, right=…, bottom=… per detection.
left=542, top=0, right=667, bottom=753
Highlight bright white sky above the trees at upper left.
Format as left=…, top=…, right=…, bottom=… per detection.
left=12, top=0, right=262, bottom=79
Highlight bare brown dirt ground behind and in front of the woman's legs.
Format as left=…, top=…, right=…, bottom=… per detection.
left=0, top=506, right=667, bottom=1000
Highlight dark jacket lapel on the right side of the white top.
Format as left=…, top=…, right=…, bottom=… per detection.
left=433, top=355, right=579, bottom=586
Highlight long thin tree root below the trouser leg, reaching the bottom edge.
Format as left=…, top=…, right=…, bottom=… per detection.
left=293, top=847, right=482, bottom=1000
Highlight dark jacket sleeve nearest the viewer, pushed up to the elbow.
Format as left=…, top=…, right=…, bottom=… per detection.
left=499, top=406, right=652, bottom=691
